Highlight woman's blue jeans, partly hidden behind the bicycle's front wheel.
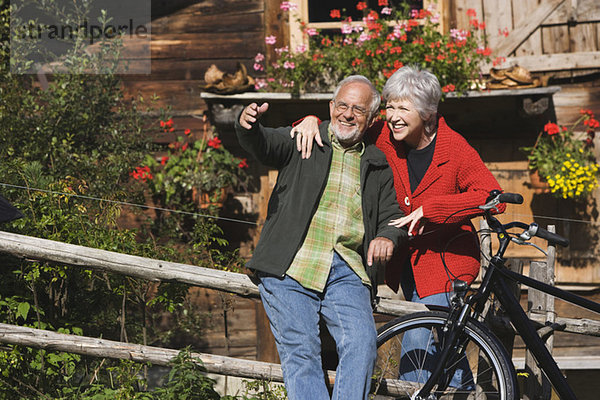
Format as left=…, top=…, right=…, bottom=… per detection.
left=398, top=265, right=474, bottom=390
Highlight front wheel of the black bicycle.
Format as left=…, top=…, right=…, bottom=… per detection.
left=373, top=311, right=519, bottom=400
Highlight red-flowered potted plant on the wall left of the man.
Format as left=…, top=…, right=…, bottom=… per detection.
left=132, top=119, right=248, bottom=208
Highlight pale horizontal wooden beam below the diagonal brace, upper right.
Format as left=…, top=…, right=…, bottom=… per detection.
left=481, top=51, right=600, bottom=73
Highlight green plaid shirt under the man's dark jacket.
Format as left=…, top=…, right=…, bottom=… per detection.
left=287, top=128, right=371, bottom=292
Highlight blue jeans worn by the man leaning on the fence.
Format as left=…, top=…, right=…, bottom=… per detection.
left=258, top=253, right=377, bottom=400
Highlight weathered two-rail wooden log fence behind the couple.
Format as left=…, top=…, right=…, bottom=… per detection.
left=0, top=231, right=600, bottom=396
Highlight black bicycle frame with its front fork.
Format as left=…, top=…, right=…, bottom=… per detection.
left=418, top=211, right=600, bottom=400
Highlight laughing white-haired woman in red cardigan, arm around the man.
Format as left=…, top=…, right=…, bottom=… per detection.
left=292, top=66, right=503, bottom=306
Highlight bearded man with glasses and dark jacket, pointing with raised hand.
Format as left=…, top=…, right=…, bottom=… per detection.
left=236, top=75, right=407, bottom=400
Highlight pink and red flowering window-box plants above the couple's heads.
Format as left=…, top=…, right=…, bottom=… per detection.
left=254, top=0, right=491, bottom=93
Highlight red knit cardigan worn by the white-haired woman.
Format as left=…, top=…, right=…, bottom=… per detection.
left=367, top=117, right=504, bottom=297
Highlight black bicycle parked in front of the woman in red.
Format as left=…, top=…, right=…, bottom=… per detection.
left=374, top=190, right=600, bottom=400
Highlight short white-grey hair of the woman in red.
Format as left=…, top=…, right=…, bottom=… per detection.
left=382, top=65, right=442, bottom=133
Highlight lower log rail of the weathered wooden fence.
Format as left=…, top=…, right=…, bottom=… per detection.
left=0, top=323, right=418, bottom=396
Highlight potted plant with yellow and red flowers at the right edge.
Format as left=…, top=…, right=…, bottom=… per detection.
left=522, top=110, right=600, bottom=200
